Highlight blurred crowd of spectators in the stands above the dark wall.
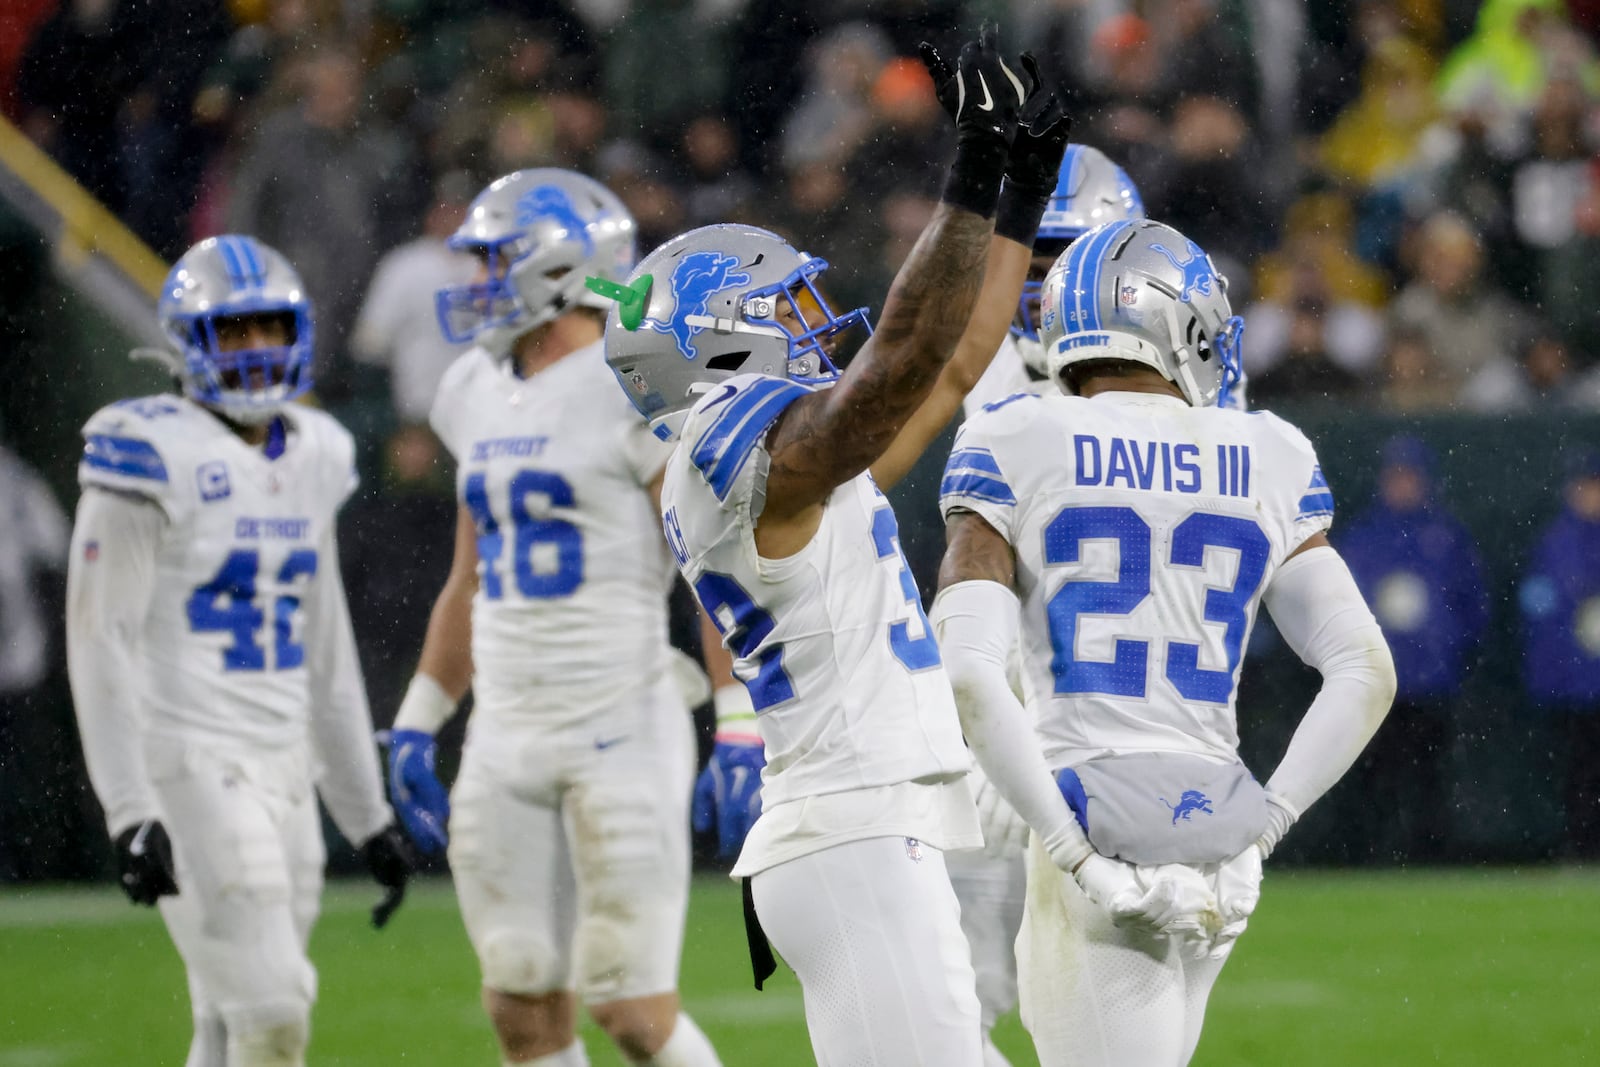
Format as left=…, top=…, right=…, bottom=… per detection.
left=9, top=0, right=1600, bottom=422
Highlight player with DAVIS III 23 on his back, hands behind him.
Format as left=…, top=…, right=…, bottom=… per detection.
left=933, top=221, right=1395, bottom=1067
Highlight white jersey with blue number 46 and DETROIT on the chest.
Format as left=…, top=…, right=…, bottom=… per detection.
left=430, top=341, right=672, bottom=726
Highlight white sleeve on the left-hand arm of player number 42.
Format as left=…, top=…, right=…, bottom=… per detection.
left=67, top=488, right=166, bottom=837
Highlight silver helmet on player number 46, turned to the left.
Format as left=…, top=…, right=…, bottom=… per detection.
left=434, top=168, right=635, bottom=358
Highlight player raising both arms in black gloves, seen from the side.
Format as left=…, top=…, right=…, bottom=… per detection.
left=598, top=24, right=1066, bottom=1067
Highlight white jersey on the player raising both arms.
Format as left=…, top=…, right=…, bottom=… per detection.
left=661, top=374, right=968, bottom=809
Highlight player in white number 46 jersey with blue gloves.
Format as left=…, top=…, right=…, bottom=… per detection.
left=389, top=170, right=718, bottom=1067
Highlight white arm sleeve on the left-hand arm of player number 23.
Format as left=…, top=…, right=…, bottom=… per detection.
left=931, top=581, right=1094, bottom=870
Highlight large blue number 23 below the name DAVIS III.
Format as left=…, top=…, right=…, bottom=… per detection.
left=1045, top=507, right=1272, bottom=704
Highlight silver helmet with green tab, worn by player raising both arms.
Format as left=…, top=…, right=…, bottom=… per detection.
left=590, top=224, right=872, bottom=440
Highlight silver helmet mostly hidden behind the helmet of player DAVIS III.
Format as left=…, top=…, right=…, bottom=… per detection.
left=1011, top=144, right=1144, bottom=378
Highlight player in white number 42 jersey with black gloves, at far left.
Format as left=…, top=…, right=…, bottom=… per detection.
left=67, top=237, right=411, bottom=1067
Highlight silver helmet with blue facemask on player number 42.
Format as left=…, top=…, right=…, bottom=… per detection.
left=154, top=235, right=312, bottom=424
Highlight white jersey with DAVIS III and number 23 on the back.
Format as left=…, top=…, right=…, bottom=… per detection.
left=939, top=392, right=1333, bottom=766
